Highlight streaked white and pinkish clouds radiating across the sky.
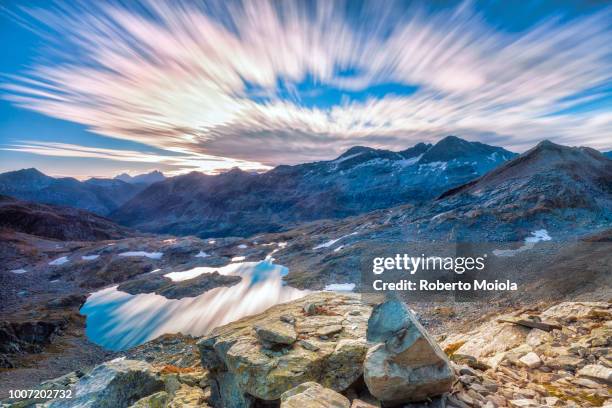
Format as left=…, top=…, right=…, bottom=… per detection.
left=5, top=0, right=612, bottom=170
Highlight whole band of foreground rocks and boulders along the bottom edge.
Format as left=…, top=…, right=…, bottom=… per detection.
left=3, top=293, right=612, bottom=408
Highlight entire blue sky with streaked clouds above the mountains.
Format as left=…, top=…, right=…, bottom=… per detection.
left=0, top=0, right=612, bottom=178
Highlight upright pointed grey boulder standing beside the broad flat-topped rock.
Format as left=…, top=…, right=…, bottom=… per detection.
left=364, top=300, right=454, bottom=406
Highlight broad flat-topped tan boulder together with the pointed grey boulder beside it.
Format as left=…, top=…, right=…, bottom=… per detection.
left=198, top=293, right=454, bottom=407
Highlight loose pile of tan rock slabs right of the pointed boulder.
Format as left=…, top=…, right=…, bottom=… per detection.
left=442, top=302, right=612, bottom=408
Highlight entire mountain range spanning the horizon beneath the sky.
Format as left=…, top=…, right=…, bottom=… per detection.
left=0, top=136, right=612, bottom=240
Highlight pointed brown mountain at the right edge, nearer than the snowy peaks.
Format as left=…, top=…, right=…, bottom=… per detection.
left=427, top=141, right=612, bottom=239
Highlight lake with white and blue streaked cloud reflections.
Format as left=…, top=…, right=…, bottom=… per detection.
left=81, top=261, right=308, bottom=350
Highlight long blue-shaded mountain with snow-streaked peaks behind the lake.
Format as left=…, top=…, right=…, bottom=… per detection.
left=111, top=136, right=515, bottom=237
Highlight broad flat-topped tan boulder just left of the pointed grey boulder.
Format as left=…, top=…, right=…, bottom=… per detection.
left=198, top=292, right=371, bottom=408
